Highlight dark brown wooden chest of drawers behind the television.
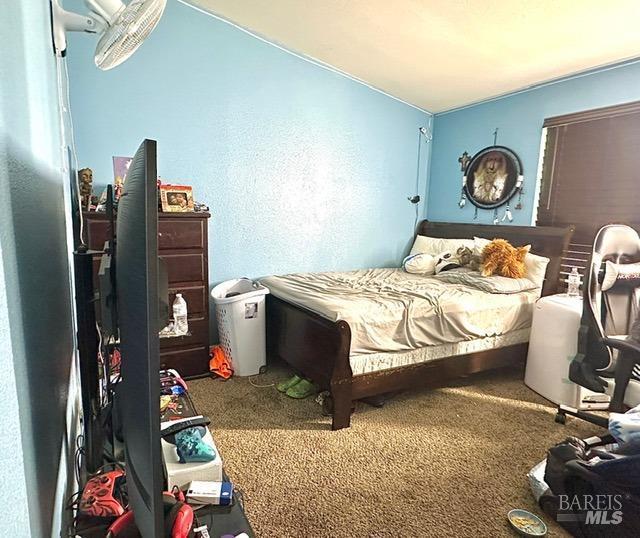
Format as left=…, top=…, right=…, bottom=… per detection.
left=84, top=212, right=210, bottom=377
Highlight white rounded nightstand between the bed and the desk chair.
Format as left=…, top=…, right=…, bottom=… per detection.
left=524, top=294, right=609, bottom=409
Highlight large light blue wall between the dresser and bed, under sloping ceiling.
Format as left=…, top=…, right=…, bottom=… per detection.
left=69, top=2, right=430, bottom=294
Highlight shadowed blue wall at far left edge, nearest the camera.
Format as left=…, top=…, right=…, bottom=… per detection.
left=0, top=0, right=73, bottom=537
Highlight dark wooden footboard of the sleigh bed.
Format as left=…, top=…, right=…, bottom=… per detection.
left=267, top=295, right=353, bottom=430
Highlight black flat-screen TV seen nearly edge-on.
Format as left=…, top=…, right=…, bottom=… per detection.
left=115, top=140, right=164, bottom=538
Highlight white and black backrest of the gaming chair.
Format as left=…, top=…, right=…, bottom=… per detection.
left=579, top=224, right=640, bottom=369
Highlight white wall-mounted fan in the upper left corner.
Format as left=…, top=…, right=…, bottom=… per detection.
left=51, top=0, right=167, bottom=71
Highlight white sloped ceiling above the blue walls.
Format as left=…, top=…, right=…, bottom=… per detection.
left=186, top=0, right=640, bottom=112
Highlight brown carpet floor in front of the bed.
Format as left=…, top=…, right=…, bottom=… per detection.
left=190, top=367, right=598, bottom=538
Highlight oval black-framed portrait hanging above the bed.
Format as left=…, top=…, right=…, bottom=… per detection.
left=464, top=146, right=522, bottom=209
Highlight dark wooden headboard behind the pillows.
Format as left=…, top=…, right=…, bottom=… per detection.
left=417, top=220, right=575, bottom=295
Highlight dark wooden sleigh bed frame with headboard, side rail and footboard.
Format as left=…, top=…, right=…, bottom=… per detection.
left=267, top=220, right=574, bottom=430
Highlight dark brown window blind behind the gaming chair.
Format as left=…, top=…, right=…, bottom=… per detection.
left=537, top=102, right=640, bottom=284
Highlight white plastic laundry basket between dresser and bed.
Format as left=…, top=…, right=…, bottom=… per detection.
left=211, top=278, right=269, bottom=377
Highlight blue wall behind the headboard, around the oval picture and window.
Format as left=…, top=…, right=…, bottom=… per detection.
left=427, top=63, right=640, bottom=225
